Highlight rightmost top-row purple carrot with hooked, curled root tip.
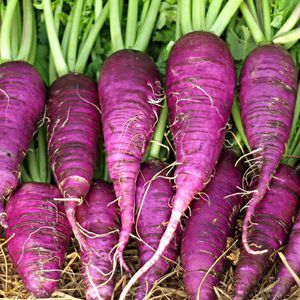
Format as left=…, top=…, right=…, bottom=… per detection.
left=240, top=45, right=297, bottom=254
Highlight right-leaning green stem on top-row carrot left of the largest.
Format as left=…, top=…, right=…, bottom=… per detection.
left=133, top=0, right=161, bottom=51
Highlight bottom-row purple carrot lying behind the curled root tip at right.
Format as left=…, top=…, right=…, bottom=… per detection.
left=234, top=165, right=300, bottom=300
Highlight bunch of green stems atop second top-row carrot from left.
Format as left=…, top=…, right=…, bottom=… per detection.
left=39, top=0, right=109, bottom=79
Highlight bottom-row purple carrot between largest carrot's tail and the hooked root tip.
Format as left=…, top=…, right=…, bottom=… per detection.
left=181, top=150, right=243, bottom=300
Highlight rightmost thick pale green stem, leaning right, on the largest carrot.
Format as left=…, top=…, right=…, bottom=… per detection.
left=209, top=0, right=243, bottom=36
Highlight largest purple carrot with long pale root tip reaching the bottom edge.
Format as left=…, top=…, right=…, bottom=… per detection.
left=120, top=32, right=235, bottom=300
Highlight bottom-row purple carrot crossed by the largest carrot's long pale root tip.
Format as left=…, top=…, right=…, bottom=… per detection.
left=136, top=160, right=181, bottom=300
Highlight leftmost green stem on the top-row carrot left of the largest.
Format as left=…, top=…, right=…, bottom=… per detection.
left=109, top=0, right=124, bottom=52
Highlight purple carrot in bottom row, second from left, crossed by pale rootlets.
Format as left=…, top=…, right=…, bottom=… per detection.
left=76, top=180, right=120, bottom=300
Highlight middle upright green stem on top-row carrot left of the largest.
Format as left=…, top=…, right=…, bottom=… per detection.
left=125, top=0, right=139, bottom=48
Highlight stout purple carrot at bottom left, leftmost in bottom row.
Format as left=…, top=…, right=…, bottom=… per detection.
left=6, top=183, right=72, bottom=298
